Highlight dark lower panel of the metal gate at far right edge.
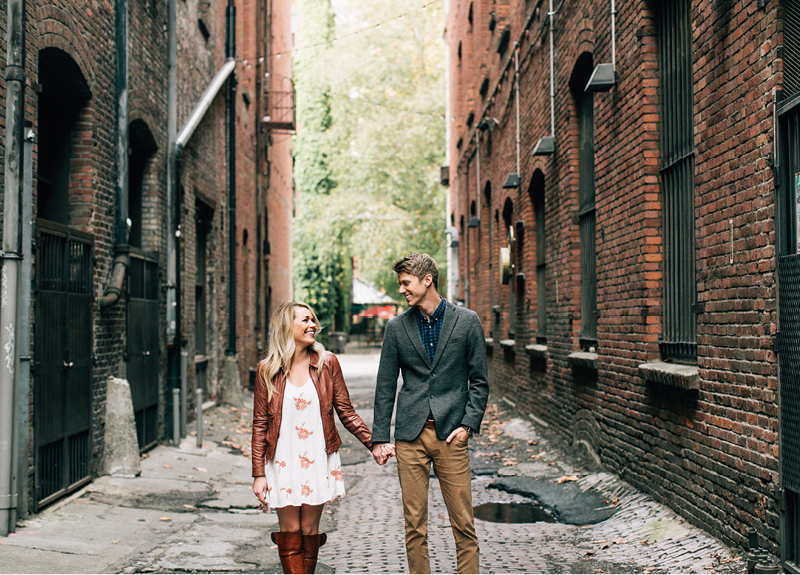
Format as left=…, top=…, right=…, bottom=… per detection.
left=778, top=254, right=800, bottom=493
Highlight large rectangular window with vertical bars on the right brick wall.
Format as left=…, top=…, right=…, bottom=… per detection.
left=658, top=0, right=697, bottom=361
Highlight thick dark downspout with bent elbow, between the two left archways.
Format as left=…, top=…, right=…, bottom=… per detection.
left=98, top=0, right=130, bottom=308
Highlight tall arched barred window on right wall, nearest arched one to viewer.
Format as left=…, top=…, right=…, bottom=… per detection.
left=570, top=52, right=597, bottom=349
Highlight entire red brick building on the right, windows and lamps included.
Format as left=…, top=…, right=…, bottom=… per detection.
left=447, top=0, right=800, bottom=569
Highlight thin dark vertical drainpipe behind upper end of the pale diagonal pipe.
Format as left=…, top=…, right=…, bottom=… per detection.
left=225, top=0, right=236, bottom=355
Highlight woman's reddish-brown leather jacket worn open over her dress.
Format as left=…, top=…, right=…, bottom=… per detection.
left=251, top=352, right=372, bottom=477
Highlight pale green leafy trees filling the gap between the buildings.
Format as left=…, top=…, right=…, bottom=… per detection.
left=294, top=0, right=446, bottom=331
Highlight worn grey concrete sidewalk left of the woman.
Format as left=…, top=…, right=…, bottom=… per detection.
left=0, top=416, right=281, bottom=573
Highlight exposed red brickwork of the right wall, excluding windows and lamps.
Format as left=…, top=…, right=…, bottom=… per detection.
left=447, top=0, right=782, bottom=550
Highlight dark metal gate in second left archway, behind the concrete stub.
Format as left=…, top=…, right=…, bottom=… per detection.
left=128, top=249, right=159, bottom=451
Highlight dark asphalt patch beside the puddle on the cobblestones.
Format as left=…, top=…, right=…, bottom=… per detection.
left=488, top=477, right=617, bottom=525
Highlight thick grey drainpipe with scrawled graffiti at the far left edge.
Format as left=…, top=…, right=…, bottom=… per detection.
left=0, top=0, right=25, bottom=536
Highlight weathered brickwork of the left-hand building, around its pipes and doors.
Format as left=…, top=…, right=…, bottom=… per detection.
left=0, top=0, right=292, bottom=512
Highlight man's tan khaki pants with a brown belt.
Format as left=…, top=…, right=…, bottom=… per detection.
left=396, top=427, right=479, bottom=573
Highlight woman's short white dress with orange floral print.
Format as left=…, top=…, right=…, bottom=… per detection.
left=264, top=377, right=344, bottom=509
